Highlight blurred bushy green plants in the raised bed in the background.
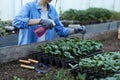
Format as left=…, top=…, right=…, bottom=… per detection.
left=60, top=8, right=120, bottom=23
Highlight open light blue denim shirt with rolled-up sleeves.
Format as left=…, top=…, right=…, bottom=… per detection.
left=12, top=0, right=70, bottom=45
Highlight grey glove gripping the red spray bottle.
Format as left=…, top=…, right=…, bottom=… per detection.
left=39, top=19, right=55, bottom=29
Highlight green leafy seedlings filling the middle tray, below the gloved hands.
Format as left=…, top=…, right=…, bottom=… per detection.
left=37, top=38, right=103, bottom=59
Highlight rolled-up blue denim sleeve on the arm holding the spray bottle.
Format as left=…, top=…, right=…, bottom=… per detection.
left=12, top=4, right=30, bottom=29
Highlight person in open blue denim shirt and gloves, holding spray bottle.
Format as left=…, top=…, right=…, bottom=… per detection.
left=12, top=0, right=86, bottom=45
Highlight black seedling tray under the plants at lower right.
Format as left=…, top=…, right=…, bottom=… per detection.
left=70, top=67, right=115, bottom=80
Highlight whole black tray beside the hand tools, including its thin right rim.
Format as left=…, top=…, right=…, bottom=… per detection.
left=35, top=50, right=103, bottom=68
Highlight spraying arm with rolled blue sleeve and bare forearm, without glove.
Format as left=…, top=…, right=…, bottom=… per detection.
left=12, top=3, right=40, bottom=29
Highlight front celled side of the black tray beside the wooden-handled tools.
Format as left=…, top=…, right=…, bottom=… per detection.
left=36, top=53, right=72, bottom=68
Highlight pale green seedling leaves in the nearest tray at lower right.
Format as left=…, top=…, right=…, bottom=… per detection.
left=71, top=52, right=120, bottom=72
